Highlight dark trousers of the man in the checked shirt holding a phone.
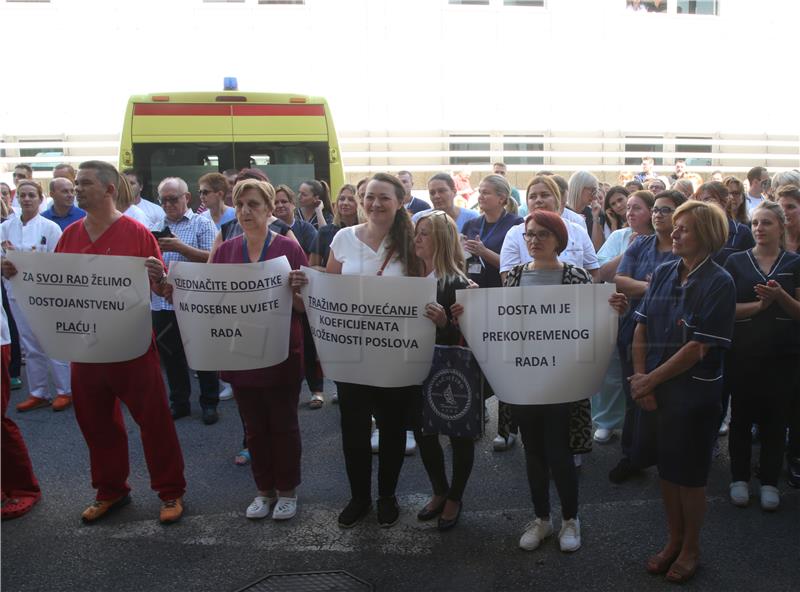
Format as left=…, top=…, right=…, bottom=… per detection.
left=152, top=310, right=219, bottom=411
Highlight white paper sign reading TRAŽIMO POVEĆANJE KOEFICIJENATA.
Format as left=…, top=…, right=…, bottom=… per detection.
left=302, top=267, right=436, bottom=387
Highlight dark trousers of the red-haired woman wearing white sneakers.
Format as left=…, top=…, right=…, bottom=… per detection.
left=510, top=403, right=578, bottom=520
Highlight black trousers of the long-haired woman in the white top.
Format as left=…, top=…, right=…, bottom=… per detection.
left=336, top=382, right=422, bottom=502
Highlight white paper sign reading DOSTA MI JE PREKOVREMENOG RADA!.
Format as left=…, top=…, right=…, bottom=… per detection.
left=456, top=284, right=617, bottom=405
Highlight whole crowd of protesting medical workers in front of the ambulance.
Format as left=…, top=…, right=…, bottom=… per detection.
left=0, top=158, right=800, bottom=582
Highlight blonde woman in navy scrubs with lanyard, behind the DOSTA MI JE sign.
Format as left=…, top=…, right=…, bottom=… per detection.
left=461, top=175, right=522, bottom=288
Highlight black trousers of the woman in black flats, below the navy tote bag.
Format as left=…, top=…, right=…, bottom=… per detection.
left=416, top=430, right=475, bottom=502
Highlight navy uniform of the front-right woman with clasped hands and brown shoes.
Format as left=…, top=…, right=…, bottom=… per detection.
left=634, top=257, right=736, bottom=487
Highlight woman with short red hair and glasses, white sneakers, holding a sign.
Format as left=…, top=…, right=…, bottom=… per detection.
left=454, top=210, right=626, bottom=552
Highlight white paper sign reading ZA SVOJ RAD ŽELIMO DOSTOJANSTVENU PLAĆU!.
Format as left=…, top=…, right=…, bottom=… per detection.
left=6, top=251, right=153, bottom=363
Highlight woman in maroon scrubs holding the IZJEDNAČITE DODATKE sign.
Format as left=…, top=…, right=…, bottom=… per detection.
left=211, top=179, right=308, bottom=520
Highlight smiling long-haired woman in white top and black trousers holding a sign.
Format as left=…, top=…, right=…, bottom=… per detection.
left=306, top=173, right=423, bottom=528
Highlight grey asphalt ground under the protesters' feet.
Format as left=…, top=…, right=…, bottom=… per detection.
left=2, top=385, right=800, bottom=592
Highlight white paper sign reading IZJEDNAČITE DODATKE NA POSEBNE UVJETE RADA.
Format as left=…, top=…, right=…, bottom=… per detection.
left=167, top=257, right=292, bottom=370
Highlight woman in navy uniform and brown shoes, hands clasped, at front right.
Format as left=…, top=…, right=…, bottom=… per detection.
left=630, top=201, right=736, bottom=582
